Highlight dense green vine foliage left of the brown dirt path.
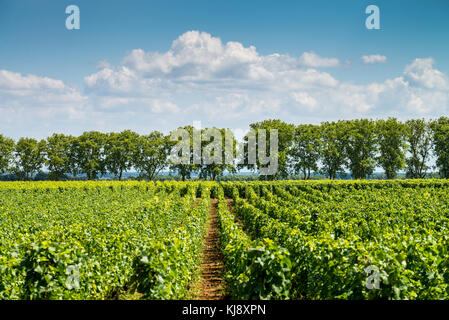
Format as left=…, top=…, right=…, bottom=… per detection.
left=0, top=182, right=210, bottom=300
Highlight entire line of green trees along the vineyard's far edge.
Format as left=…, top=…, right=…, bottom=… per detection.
left=0, top=117, right=449, bottom=180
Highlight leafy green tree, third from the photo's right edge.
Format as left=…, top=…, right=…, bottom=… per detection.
left=376, top=118, right=407, bottom=179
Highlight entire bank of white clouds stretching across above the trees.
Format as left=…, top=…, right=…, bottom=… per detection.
left=0, top=31, right=449, bottom=135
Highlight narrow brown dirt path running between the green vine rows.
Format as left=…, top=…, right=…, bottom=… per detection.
left=198, top=199, right=226, bottom=300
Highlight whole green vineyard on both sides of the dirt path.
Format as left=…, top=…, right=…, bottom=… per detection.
left=0, top=180, right=449, bottom=300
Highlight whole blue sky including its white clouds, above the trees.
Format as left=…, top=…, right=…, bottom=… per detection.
left=0, top=0, right=449, bottom=138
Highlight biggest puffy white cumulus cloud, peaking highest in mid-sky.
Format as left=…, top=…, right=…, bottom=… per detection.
left=85, top=31, right=340, bottom=88
